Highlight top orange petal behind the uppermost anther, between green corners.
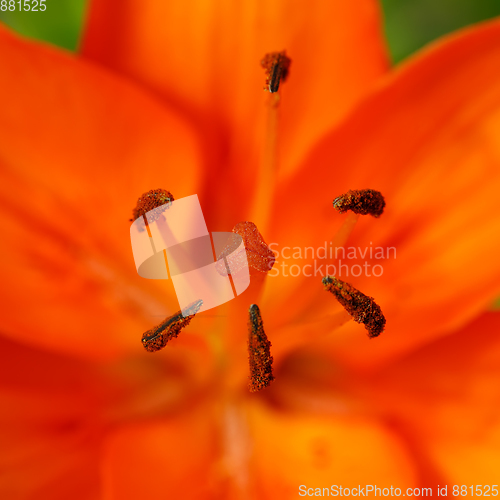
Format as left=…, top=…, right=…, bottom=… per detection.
left=82, top=0, right=387, bottom=226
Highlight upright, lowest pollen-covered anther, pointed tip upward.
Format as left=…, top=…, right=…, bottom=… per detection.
left=248, top=304, right=274, bottom=392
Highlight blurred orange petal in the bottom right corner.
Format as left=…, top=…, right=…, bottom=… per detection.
left=372, top=313, right=500, bottom=484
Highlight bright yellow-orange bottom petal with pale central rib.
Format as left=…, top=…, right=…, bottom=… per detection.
left=102, top=376, right=415, bottom=500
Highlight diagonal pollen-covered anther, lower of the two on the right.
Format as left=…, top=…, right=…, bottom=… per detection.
left=323, top=276, right=385, bottom=338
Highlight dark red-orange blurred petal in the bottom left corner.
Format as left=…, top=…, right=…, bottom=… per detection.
left=0, top=330, right=217, bottom=500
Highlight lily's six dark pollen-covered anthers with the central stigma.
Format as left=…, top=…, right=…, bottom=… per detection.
left=131, top=59, right=386, bottom=392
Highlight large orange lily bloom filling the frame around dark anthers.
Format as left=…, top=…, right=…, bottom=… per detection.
left=0, top=0, right=500, bottom=500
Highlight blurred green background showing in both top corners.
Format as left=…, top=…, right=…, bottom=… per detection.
left=0, top=0, right=500, bottom=62
